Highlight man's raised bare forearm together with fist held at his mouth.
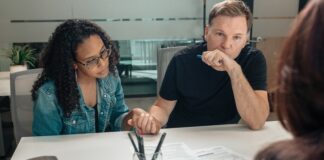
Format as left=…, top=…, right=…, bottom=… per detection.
left=202, top=49, right=269, bottom=130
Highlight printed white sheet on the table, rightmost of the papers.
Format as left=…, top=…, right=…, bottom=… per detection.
left=195, top=146, right=248, bottom=160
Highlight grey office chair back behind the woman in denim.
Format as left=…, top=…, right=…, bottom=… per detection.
left=10, top=68, right=43, bottom=144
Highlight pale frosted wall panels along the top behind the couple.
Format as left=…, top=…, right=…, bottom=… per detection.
left=0, top=0, right=298, bottom=44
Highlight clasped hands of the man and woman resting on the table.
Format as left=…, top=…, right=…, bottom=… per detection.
left=128, top=108, right=162, bottom=134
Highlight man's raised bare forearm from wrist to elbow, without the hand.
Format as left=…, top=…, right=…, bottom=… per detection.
left=228, top=66, right=269, bottom=129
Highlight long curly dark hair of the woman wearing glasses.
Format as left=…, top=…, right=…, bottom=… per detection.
left=32, top=19, right=119, bottom=117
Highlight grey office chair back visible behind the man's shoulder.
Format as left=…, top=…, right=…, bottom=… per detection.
left=156, top=46, right=186, bottom=95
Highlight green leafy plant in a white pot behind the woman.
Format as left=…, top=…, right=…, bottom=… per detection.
left=8, top=45, right=37, bottom=72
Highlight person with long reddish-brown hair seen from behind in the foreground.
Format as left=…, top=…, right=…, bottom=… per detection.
left=255, top=0, right=324, bottom=160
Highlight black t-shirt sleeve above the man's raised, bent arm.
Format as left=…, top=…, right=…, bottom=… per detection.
left=245, top=50, right=267, bottom=90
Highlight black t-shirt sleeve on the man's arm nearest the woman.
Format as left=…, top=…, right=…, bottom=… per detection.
left=160, top=57, right=178, bottom=100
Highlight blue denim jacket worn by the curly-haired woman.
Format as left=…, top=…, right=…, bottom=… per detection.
left=33, top=74, right=128, bottom=136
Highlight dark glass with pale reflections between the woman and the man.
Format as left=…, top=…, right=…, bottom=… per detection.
left=116, top=39, right=201, bottom=97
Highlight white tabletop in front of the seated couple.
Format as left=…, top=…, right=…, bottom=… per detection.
left=12, top=121, right=291, bottom=160
